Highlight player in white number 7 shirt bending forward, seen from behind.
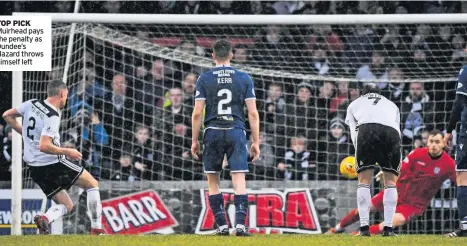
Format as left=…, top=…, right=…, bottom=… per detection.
left=345, top=83, right=401, bottom=236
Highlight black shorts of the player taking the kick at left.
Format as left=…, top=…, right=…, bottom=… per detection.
left=29, top=160, right=84, bottom=199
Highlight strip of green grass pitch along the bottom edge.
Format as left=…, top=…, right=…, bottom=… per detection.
left=0, top=235, right=467, bottom=246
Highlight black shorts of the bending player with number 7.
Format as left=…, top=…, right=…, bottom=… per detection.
left=355, top=123, right=402, bottom=175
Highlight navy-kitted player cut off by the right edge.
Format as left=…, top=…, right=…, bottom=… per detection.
left=444, top=66, right=467, bottom=237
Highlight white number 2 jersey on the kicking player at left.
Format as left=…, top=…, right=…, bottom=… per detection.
left=16, top=99, right=65, bottom=167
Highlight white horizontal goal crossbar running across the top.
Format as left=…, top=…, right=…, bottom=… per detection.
left=13, top=12, right=467, bottom=25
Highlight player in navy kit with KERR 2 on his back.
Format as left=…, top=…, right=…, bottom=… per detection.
left=191, top=40, right=260, bottom=236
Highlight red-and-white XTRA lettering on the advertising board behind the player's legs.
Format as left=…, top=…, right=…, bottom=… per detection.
left=195, top=189, right=321, bottom=234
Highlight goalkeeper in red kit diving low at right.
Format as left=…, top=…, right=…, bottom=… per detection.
left=328, top=130, right=456, bottom=234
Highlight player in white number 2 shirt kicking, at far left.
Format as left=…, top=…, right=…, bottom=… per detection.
left=3, top=81, right=104, bottom=235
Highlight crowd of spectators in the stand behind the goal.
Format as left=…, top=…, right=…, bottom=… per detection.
left=0, top=1, right=467, bottom=181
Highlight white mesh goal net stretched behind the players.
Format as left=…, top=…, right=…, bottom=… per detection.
left=24, top=24, right=460, bottom=233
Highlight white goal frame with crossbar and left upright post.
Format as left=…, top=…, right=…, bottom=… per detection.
left=11, top=11, right=467, bottom=235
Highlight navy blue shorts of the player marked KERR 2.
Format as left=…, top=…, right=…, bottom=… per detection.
left=203, top=128, right=248, bottom=173
